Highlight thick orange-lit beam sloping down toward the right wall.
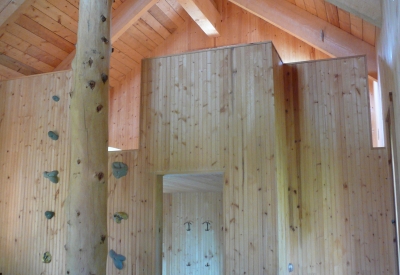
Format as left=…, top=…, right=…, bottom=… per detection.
left=229, top=0, right=377, bottom=79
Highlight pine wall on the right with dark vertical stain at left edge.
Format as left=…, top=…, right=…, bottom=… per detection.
left=283, top=57, right=396, bottom=274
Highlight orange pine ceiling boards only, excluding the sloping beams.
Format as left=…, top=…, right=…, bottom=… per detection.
left=0, top=0, right=379, bottom=86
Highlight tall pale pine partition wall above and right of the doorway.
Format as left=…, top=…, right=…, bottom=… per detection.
left=136, top=43, right=278, bottom=274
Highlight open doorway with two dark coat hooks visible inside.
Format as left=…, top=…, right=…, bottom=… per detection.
left=156, top=172, right=224, bottom=275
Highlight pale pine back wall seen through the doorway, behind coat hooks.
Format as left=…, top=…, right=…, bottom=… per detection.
left=162, top=192, right=224, bottom=275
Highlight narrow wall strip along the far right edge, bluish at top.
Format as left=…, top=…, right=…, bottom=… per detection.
left=377, top=0, right=400, bottom=270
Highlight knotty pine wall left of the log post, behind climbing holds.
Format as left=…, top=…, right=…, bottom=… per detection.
left=0, top=72, right=72, bottom=275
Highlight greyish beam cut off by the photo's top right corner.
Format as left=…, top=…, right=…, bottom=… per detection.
left=326, top=0, right=382, bottom=28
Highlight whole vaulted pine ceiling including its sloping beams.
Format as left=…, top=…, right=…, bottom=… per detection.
left=0, top=0, right=379, bottom=85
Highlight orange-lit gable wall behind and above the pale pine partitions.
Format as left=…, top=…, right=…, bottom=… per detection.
left=109, top=0, right=328, bottom=150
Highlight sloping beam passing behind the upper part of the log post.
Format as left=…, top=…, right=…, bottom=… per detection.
left=54, top=0, right=158, bottom=71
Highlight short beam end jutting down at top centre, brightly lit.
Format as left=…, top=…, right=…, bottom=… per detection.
left=178, top=0, right=221, bottom=37
